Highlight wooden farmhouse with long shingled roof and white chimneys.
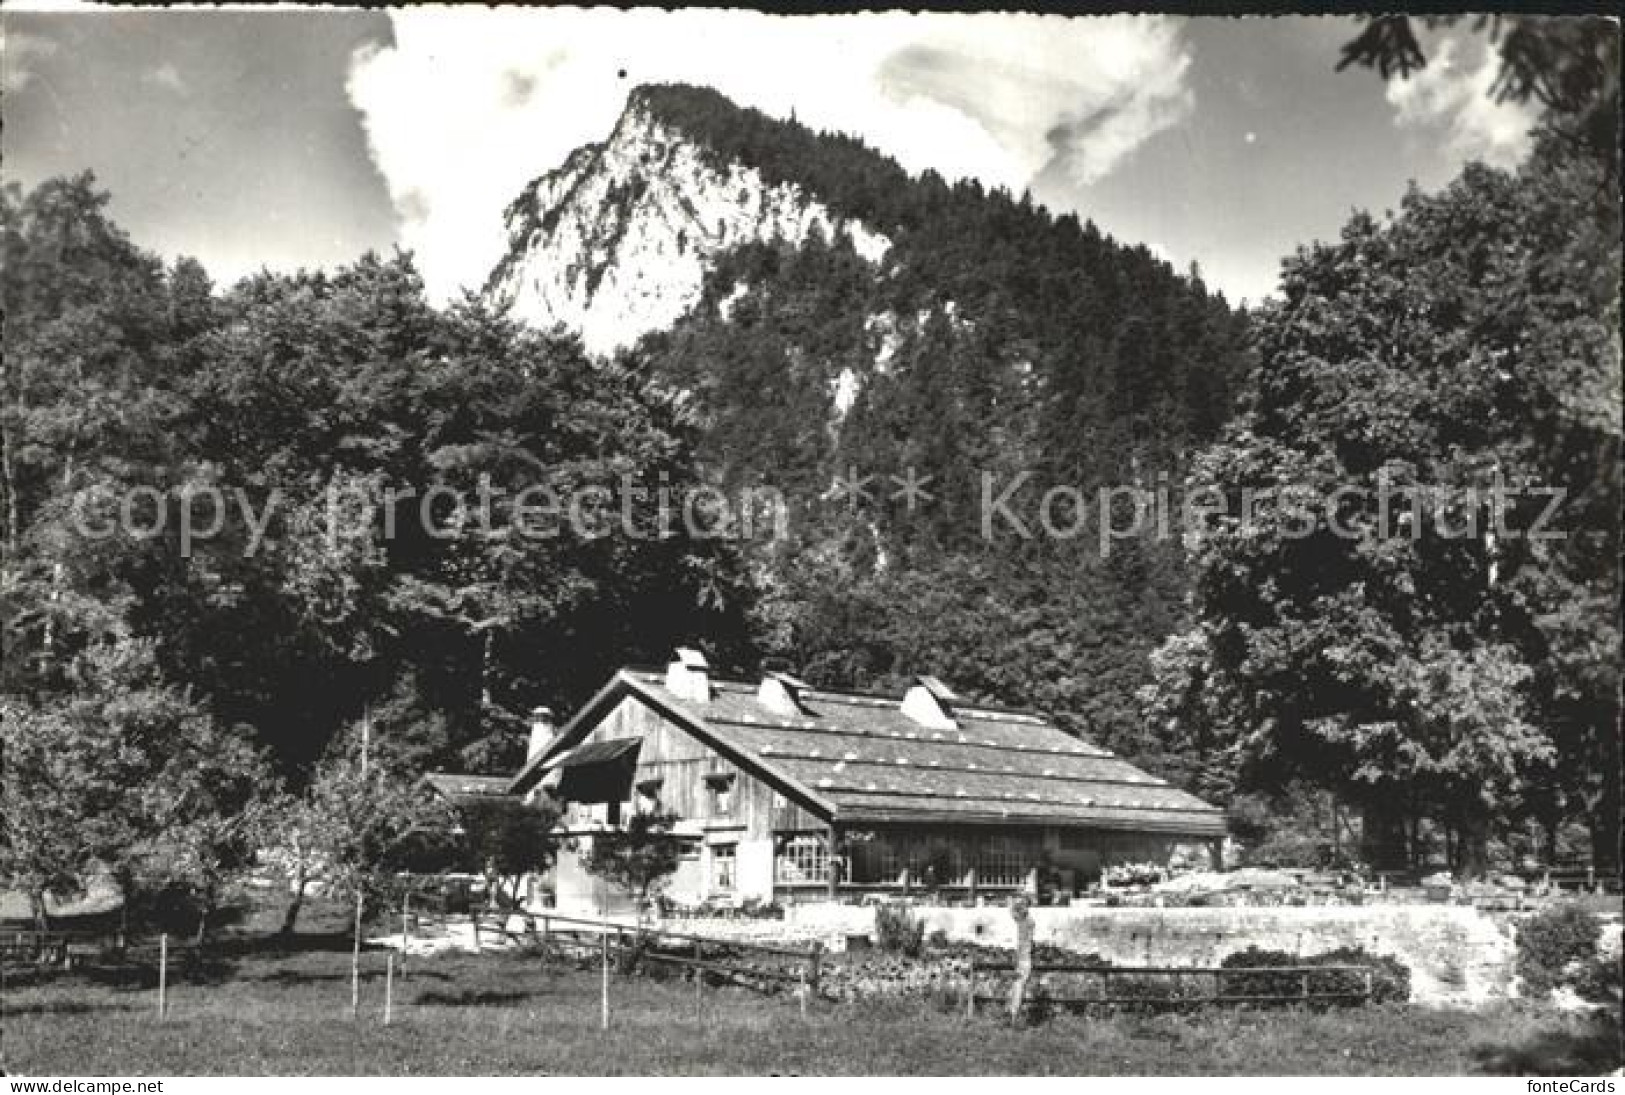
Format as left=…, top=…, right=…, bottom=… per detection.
left=509, top=650, right=1225, bottom=910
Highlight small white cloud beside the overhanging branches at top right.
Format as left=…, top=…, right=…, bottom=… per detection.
left=1386, top=37, right=1536, bottom=167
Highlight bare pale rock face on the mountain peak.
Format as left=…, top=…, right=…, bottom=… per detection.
left=486, top=91, right=891, bottom=354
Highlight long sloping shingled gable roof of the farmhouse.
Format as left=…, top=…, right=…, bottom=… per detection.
left=512, top=669, right=1225, bottom=837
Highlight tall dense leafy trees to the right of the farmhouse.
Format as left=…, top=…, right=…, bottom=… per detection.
left=1146, top=136, right=1620, bottom=869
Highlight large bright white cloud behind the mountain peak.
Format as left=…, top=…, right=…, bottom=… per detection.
left=349, top=8, right=1191, bottom=297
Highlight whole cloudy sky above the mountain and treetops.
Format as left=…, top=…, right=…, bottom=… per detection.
left=0, top=3, right=1532, bottom=302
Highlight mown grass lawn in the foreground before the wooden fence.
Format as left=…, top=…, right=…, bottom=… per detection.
left=3, top=896, right=1620, bottom=1076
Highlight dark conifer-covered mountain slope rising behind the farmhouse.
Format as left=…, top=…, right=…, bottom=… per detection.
left=614, top=86, right=1248, bottom=759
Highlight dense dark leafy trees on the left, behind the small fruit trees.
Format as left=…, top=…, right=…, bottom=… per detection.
left=3, top=177, right=760, bottom=775
